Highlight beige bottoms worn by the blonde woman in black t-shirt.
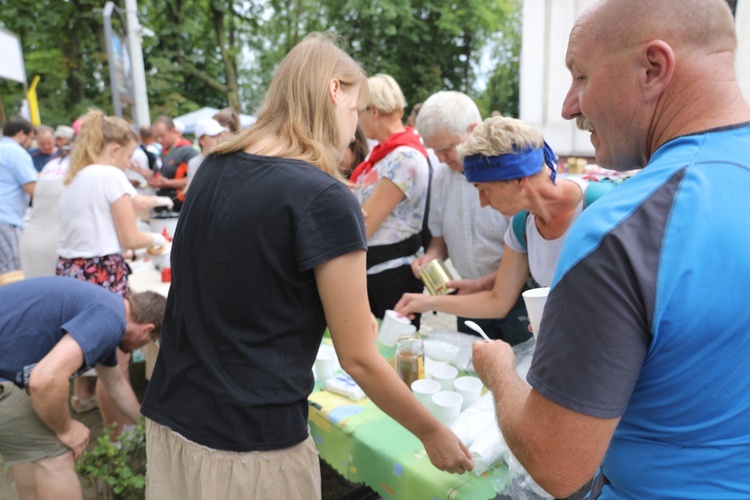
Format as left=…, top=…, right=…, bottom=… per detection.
left=146, top=419, right=321, bottom=500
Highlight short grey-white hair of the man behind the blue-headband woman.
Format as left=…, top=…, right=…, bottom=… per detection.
left=417, top=90, right=482, bottom=139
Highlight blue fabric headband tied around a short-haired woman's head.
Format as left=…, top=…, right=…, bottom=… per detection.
left=464, top=142, right=557, bottom=184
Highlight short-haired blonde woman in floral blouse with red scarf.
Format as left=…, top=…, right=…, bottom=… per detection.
left=351, top=74, right=430, bottom=327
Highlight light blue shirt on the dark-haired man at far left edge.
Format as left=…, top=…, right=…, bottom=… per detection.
left=0, top=137, right=38, bottom=227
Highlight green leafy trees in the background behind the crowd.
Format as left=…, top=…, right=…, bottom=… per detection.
left=0, top=0, right=521, bottom=126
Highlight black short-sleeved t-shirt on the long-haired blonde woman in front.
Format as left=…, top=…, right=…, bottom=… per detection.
left=142, top=153, right=367, bottom=451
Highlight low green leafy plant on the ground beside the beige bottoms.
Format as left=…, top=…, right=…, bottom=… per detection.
left=76, top=422, right=146, bottom=499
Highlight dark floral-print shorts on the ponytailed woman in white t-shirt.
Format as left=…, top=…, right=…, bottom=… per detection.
left=57, top=254, right=130, bottom=298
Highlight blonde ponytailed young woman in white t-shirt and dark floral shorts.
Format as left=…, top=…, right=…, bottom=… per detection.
left=57, top=110, right=166, bottom=428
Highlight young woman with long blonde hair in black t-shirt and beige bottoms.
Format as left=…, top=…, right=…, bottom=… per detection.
left=142, top=34, right=472, bottom=499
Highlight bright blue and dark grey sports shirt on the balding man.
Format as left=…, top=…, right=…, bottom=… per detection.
left=528, top=124, right=750, bottom=499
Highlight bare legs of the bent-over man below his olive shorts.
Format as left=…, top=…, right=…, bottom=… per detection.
left=13, top=451, right=83, bottom=500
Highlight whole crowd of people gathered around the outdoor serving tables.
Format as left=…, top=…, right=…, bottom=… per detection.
left=0, top=0, right=750, bottom=499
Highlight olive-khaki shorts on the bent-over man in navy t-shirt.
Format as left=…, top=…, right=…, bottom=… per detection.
left=0, top=382, right=70, bottom=467
